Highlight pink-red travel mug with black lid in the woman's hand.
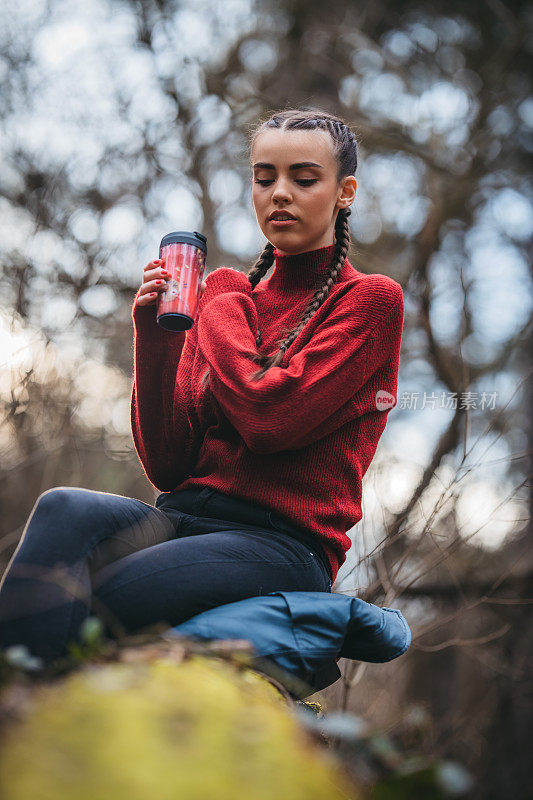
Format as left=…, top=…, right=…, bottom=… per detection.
left=156, top=231, right=207, bottom=331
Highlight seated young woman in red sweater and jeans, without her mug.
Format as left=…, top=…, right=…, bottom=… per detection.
left=0, top=110, right=403, bottom=661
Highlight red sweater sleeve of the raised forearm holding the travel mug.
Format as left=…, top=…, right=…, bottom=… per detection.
left=131, top=295, right=198, bottom=492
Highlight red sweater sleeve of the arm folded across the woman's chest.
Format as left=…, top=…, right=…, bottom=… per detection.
left=198, top=275, right=404, bottom=453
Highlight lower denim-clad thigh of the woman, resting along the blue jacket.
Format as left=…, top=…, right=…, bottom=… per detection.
left=93, top=512, right=330, bottom=632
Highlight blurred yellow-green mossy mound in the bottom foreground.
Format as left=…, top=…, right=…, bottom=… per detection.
left=0, top=656, right=355, bottom=800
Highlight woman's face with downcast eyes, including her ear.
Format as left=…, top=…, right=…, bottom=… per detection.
left=252, top=128, right=357, bottom=255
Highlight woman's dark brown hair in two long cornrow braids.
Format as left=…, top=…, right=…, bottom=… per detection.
left=202, top=109, right=357, bottom=385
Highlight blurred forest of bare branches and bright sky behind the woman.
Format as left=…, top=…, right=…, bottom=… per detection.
left=0, top=0, right=533, bottom=799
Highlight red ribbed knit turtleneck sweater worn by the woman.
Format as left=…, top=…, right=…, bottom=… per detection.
left=131, top=245, right=404, bottom=581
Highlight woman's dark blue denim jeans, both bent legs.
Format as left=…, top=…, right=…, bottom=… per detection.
left=0, top=487, right=331, bottom=664
